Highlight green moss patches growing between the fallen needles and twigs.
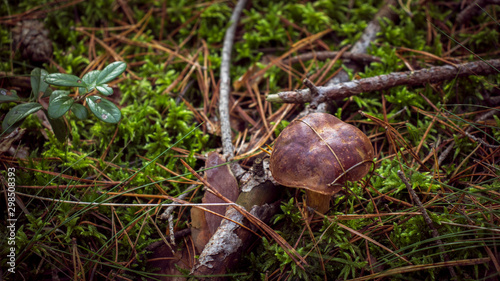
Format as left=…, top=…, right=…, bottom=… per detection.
left=0, top=0, right=500, bottom=280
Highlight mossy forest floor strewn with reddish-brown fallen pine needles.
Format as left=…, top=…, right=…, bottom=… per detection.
left=0, top=0, right=500, bottom=280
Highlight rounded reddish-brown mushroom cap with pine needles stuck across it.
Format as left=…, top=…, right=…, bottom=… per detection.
left=270, top=113, right=373, bottom=195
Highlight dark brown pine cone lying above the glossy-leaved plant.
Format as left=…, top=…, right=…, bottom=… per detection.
left=12, top=20, right=52, bottom=62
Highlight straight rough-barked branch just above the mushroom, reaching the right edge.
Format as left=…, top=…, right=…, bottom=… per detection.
left=267, top=59, right=500, bottom=103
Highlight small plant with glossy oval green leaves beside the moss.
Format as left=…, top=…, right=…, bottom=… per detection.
left=0, top=62, right=127, bottom=142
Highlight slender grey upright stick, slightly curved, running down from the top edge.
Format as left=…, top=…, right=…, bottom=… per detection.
left=219, top=0, right=247, bottom=160
